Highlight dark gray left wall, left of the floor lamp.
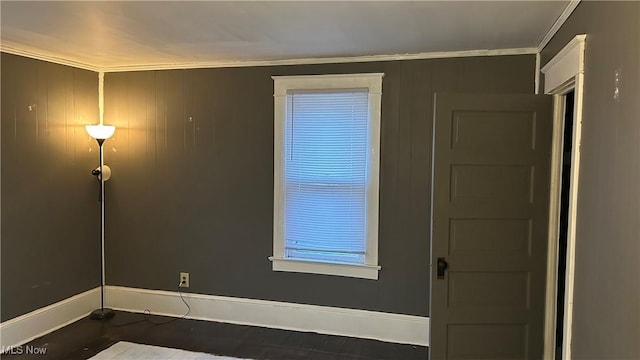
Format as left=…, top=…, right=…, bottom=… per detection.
left=0, top=53, right=100, bottom=321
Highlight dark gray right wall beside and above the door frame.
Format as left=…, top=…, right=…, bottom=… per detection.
left=542, top=1, right=640, bottom=359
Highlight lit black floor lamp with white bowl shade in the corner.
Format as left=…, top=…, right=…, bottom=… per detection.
left=86, top=124, right=116, bottom=320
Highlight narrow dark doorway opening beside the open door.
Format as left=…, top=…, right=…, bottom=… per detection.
left=555, top=90, right=575, bottom=359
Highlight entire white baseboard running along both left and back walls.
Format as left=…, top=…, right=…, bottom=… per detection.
left=0, top=286, right=429, bottom=349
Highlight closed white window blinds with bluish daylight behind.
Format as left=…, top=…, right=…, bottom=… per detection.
left=284, top=89, right=369, bottom=264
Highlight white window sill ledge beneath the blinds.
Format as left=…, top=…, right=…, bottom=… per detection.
left=269, top=256, right=381, bottom=280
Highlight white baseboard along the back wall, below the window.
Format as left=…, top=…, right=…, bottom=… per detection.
left=106, top=286, right=429, bottom=346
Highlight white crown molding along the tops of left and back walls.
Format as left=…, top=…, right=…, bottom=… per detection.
left=0, top=42, right=538, bottom=73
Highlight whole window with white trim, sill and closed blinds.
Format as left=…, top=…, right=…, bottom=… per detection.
left=269, top=73, right=383, bottom=279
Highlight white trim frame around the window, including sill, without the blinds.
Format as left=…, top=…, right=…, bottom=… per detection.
left=269, top=73, right=384, bottom=280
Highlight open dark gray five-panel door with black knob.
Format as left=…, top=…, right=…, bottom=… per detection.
left=429, top=94, right=553, bottom=360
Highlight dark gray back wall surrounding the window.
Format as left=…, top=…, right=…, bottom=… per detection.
left=105, top=55, right=535, bottom=315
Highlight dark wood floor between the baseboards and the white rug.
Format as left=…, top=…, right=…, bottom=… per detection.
left=2, top=311, right=427, bottom=360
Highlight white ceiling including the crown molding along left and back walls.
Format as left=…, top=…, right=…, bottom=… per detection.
left=0, top=0, right=570, bottom=71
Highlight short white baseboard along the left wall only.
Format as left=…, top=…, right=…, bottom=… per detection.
left=0, top=287, right=100, bottom=349
